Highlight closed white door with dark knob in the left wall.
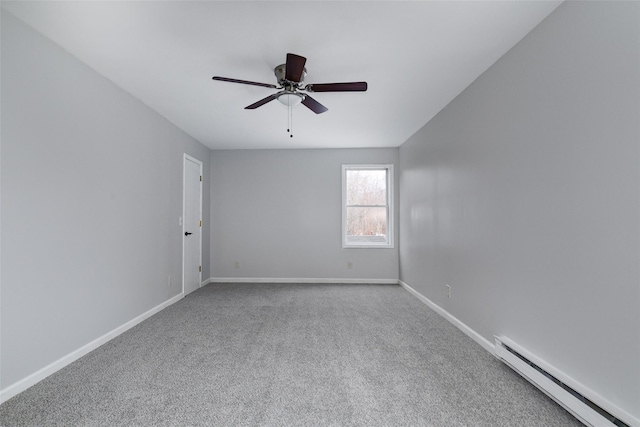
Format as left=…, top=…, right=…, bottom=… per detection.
left=182, top=154, right=202, bottom=295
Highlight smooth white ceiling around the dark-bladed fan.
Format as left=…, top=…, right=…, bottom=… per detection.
left=2, top=1, right=561, bottom=149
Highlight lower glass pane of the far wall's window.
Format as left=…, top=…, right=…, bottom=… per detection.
left=346, top=207, right=387, bottom=243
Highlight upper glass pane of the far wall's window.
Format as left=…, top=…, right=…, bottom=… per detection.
left=346, top=169, right=387, bottom=205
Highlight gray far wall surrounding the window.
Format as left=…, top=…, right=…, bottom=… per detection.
left=211, top=148, right=398, bottom=280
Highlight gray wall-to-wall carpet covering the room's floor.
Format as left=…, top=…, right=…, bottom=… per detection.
left=0, top=284, right=581, bottom=427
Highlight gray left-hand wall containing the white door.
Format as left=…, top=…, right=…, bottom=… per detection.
left=0, top=11, right=209, bottom=389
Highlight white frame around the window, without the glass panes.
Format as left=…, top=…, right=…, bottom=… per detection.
left=342, top=164, right=394, bottom=249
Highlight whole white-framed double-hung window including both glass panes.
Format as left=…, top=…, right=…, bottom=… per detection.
left=342, top=165, right=393, bottom=248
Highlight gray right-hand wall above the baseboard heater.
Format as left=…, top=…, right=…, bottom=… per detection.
left=399, top=2, right=640, bottom=418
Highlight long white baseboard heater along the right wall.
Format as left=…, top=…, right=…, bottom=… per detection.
left=495, top=337, right=630, bottom=427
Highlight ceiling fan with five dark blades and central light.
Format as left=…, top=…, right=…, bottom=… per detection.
left=213, top=53, right=367, bottom=114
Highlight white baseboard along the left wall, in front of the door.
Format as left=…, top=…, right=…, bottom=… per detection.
left=0, top=293, right=183, bottom=404
